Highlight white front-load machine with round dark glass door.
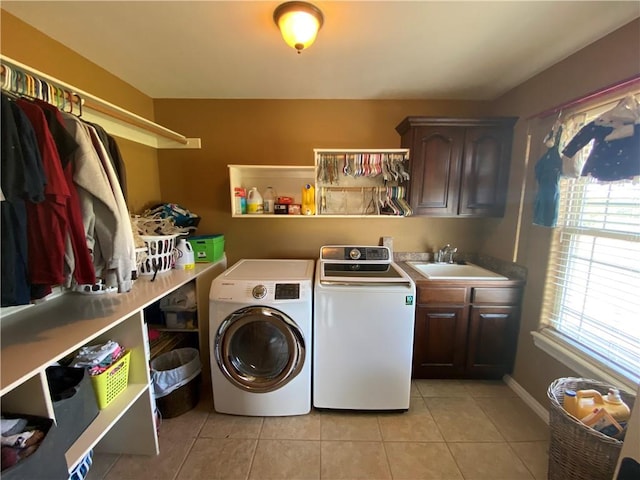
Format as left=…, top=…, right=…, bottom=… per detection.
left=209, top=259, right=315, bottom=416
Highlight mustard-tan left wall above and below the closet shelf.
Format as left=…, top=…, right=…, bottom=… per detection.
left=0, top=10, right=160, bottom=212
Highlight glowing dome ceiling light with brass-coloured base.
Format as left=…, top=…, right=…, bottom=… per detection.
left=273, top=2, right=324, bottom=53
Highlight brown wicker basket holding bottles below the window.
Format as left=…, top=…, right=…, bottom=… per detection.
left=547, top=377, right=635, bottom=480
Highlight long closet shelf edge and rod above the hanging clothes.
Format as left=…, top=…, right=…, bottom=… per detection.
left=0, top=55, right=200, bottom=148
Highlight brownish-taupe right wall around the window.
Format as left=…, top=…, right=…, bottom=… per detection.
left=482, top=20, right=640, bottom=406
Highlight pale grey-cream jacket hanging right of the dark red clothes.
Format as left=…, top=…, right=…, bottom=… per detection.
left=62, top=113, right=135, bottom=292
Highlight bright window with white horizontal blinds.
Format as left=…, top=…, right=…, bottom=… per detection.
left=542, top=94, right=640, bottom=390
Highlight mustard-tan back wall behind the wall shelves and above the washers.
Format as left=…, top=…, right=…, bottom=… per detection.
left=155, top=100, right=487, bottom=262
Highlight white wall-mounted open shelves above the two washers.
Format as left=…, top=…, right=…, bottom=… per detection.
left=228, top=148, right=409, bottom=219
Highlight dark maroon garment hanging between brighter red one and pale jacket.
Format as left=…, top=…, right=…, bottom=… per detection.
left=35, top=100, right=96, bottom=288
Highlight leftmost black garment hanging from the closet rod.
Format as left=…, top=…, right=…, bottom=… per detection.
left=0, top=95, right=45, bottom=307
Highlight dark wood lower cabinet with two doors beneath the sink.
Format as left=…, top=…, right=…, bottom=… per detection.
left=413, top=286, right=521, bottom=378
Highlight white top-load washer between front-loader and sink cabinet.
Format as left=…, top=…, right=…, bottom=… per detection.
left=313, top=245, right=416, bottom=410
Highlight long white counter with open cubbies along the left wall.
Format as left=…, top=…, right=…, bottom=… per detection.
left=0, top=259, right=226, bottom=471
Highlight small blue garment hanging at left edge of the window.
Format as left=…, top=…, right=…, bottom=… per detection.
left=533, top=127, right=562, bottom=227
